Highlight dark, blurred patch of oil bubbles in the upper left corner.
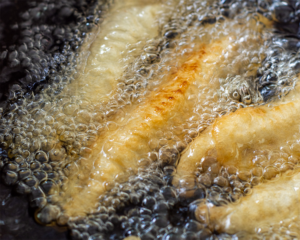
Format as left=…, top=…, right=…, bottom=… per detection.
left=0, top=1, right=109, bottom=106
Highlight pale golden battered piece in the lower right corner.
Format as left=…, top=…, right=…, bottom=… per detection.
left=195, top=169, right=300, bottom=236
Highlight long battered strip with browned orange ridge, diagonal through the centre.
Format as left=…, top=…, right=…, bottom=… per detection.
left=62, top=38, right=230, bottom=216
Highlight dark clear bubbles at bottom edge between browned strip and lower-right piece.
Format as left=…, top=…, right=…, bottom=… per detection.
left=68, top=165, right=211, bottom=239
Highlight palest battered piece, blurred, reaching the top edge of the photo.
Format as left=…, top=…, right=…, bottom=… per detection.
left=69, top=0, right=163, bottom=102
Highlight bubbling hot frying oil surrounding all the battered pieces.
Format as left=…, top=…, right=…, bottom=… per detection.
left=0, top=0, right=300, bottom=240
